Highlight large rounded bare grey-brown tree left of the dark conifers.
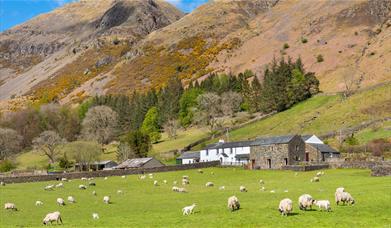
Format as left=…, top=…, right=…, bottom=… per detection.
left=81, top=106, right=118, bottom=144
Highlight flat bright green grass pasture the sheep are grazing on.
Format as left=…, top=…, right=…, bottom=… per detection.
left=0, top=168, right=391, bottom=227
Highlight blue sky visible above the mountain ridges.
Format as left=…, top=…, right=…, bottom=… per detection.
left=0, top=0, right=208, bottom=32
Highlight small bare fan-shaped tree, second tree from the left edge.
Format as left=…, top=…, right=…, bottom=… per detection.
left=33, top=131, right=66, bottom=163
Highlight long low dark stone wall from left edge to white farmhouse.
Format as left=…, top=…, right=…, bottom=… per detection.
left=0, top=161, right=220, bottom=183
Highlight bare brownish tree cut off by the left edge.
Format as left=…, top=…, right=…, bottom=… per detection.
left=0, top=128, right=23, bottom=160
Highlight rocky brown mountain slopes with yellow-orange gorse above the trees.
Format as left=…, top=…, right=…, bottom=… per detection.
left=0, top=0, right=391, bottom=103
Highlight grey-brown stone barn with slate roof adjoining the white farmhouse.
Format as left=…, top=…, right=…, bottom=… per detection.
left=249, top=135, right=305, bottom=169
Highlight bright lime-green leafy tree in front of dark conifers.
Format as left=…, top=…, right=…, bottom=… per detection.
left=141, top=107, right=161, bottom=142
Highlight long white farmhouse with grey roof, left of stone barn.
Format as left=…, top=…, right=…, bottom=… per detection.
left=200, top=140, right=252, bottom=165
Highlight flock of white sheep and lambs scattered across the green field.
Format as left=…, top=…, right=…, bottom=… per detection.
left=1, top=169, right=355, bottom=225
